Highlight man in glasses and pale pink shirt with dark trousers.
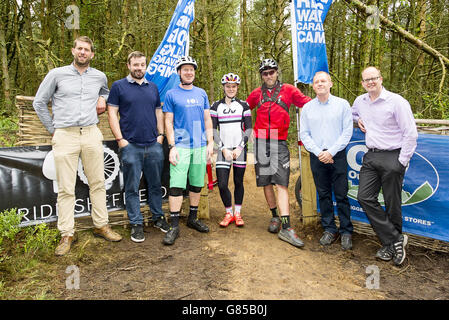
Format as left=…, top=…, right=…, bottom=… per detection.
left=352, top=67, right=418, bottom=265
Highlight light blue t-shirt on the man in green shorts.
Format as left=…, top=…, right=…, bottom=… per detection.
left=162, top=86, right=210, bottom=148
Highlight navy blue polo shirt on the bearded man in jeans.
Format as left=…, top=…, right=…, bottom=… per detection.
left=108, top=75, right=161, bottom=146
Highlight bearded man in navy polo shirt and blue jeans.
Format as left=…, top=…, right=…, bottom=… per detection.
left=108, top=51, right=170, bottom=242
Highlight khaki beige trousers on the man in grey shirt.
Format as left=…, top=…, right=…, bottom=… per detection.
left=52, top=125, right=108, bottom=236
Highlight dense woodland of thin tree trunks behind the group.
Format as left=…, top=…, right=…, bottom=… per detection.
left=0, top=0, right=449, bottom=132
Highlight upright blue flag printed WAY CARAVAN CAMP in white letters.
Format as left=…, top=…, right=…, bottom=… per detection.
left=291, top=0, right=332, bottom=83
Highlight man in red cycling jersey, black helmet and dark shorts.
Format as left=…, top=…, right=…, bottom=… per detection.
left=246, top=59, right=311, bottom=247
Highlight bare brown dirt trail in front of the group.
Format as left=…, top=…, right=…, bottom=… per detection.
left=49, top=156, right=449, bottom=300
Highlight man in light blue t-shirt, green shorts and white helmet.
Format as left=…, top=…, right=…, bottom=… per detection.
left=163, top=56, right=214, bottom=245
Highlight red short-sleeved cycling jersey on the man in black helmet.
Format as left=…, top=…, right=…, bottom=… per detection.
left=246, top=83, right=312, bottom=140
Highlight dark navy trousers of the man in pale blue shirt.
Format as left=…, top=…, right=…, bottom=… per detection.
left=310, top=150, right=353, bottom=234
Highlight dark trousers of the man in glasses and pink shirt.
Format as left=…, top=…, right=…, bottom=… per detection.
left=357, top=150, right=405, bottom=246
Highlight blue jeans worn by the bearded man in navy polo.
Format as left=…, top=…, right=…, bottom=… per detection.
left=120, top=142, right=164, bottom=224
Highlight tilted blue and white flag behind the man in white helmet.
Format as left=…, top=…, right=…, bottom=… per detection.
left=145, top=0, right=195, bottom=102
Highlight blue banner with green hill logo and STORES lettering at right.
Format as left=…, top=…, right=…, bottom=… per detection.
left=338, top=129, right=449, bottom=241
